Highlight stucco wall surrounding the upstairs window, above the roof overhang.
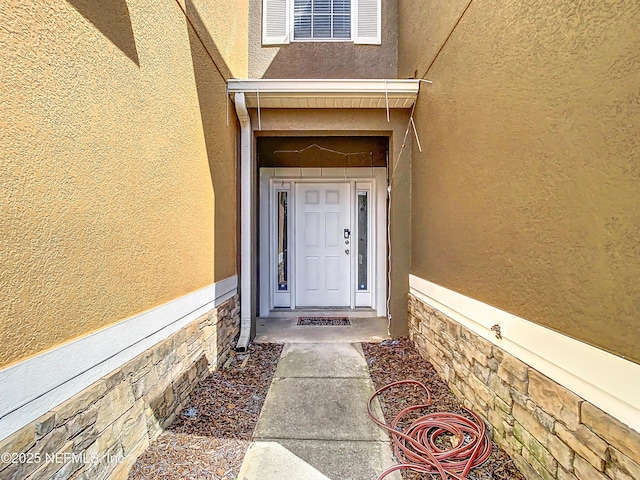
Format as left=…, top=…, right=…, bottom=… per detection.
left=249, top=0, right=398, bottom=78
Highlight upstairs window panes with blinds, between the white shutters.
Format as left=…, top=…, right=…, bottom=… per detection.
left=293, top=0, right=351, bottom=40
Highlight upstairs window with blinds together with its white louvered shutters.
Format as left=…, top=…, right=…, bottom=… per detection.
left=262, top=0, right=382, bottom=45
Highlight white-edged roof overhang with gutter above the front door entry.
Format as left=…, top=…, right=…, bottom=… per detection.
left=227, top=79, right=420, bottom=108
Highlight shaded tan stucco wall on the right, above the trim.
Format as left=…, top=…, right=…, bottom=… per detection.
left=399, top=0, right=640, bottom=362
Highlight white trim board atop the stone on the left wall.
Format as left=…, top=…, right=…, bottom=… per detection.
left=0, top=275, right=238, bottom=440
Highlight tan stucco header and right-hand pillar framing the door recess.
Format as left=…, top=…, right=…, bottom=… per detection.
left=250, top=109, right=411, bottom=337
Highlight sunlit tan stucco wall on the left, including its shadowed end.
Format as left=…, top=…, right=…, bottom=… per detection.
left=0, top=0, right=236, bottom=367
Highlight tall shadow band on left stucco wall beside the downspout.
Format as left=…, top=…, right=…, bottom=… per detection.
left=186, top=0, right=237, bottom=281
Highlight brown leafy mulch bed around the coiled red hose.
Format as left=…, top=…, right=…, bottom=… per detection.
left=362, top=338, right=524, bottom=480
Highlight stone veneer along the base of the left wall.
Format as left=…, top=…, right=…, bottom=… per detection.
left=0, top=295, right=240, bottom=480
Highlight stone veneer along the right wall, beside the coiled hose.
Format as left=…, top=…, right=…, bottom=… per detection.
left=409, top=295, right=640, bottom=480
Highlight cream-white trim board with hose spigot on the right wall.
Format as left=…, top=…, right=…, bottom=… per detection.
left=409, top=275, right=640, bottom=432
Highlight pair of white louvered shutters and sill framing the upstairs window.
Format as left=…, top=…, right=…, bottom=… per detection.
left=262, top=0, right=382, bottom=45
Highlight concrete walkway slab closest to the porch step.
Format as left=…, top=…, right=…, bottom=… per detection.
left=275, top=343, right=369, bottom=378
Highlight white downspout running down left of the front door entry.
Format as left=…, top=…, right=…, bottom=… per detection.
left=235, top=92, right=253, bottom=351
